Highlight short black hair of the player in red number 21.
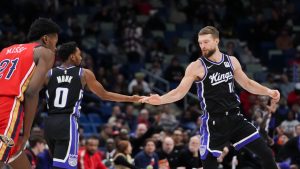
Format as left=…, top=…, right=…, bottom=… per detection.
left=27, top=18, right=60, bottom=41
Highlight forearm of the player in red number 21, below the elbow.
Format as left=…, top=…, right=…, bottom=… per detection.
left=24, top=92, right=39, bottom=137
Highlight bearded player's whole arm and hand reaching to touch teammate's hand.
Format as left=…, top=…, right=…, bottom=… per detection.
left=140, top=62, right=200, bottom=105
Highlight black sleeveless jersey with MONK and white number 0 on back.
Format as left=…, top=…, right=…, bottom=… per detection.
left=46, top=66, right=83, bottom=115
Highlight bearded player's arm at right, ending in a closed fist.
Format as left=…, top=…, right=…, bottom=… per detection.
left=230, top=56, right=280, bottom=102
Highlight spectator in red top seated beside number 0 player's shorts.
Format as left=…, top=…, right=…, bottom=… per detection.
left=77, top=136, right=106, bottom=169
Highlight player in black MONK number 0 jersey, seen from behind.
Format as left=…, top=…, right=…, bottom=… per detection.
left=45, top=42, right=142, bottom=169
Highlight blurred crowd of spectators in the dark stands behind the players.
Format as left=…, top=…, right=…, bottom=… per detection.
left=0, top=0, right=300, bottom=169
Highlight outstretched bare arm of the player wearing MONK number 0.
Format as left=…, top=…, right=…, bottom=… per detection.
left=83, top=69, right=143, bottom=102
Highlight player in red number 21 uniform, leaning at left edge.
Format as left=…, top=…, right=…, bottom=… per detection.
left=0, top=18, right=59, bottom=169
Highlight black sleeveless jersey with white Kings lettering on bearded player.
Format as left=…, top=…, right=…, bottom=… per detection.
left=196, top=54, right=240, bottom=113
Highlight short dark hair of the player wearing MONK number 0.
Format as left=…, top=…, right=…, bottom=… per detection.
left=56, top=41, right=77, bottom=62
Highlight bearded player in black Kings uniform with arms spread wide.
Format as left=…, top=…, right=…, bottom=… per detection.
left=140, top=26, right=280, bottom=169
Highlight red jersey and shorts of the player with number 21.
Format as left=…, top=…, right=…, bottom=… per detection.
left=0, top=43, right=40, bottom=162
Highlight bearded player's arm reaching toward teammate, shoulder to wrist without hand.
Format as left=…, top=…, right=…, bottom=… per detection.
left=156, top=60, right=204, bottom=105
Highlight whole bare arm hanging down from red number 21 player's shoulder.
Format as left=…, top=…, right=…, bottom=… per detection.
left=24, top=47, right=55, bottom=137
